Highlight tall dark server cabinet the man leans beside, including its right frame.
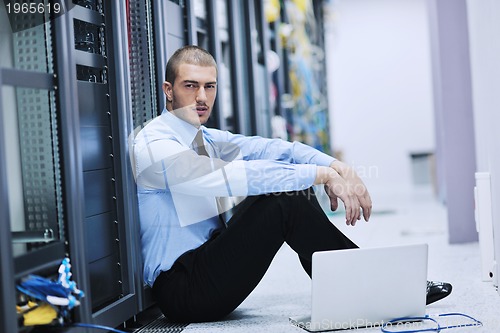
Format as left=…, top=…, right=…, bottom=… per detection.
left=66, top=0, right=140, bottom=326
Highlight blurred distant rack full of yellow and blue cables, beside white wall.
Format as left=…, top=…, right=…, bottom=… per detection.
left=268, top=0, right=331, bottom=152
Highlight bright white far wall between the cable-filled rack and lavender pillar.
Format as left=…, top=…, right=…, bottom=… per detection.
left=326, top=0, right=435, bottom=191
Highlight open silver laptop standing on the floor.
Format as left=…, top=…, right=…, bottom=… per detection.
left=290, top=244, right=428, bottom=332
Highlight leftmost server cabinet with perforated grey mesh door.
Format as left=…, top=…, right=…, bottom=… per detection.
left=0, top=2, right=66, bottom=332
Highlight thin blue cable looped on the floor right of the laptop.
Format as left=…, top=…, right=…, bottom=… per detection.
left=380, top=312, right=483, bottom=333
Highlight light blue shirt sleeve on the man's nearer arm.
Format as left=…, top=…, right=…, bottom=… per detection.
left=134, top=132, right=316, bottom=197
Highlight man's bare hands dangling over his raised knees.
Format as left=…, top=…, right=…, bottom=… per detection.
left=314, top=161, right=372, bottom=226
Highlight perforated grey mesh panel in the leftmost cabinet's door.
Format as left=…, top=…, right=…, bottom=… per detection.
left=13, top=11, right=64, bottom=237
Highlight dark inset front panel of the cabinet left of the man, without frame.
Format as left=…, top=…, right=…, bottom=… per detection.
left=73, top=4, right=123, bottom=312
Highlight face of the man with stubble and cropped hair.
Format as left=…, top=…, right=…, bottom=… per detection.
left=163, top=64, right=217, bottom=127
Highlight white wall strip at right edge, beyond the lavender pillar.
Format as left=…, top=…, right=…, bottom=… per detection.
left=467, top=0, right=500, bottom=293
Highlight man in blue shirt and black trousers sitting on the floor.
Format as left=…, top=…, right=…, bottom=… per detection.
left=132, top=46, right=451, bottom=322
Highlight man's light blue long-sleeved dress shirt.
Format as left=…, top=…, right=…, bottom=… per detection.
left=131, top=110, right=335, bottom=286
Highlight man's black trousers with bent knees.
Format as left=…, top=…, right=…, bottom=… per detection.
left=153, top=189, right=356, bottom=323
